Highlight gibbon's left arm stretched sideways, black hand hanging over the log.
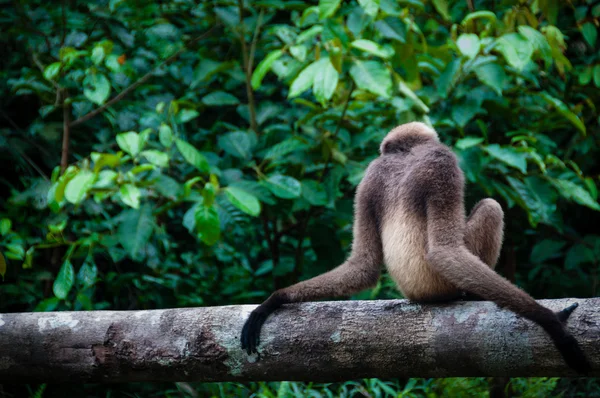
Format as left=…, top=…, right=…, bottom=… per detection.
left=241, top=190, right=383, bottom=354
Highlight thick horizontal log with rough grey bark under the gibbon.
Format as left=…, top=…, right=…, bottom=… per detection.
left=0, top=298, right=600, bottom=384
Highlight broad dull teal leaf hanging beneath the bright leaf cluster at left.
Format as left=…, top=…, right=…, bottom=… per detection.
left=117, top=205, right=154, bottom=261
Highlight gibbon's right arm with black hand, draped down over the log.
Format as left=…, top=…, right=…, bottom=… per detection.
left=426, top=153, right=591, bottom=373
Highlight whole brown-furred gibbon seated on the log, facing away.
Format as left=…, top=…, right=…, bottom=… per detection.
left=242, top=122, right=590, bottom=372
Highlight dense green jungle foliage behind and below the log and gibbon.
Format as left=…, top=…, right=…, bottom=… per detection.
left=0, top=0, right=600, bottom=397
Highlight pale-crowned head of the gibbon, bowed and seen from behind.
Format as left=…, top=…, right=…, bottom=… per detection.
left=379, top=122, right=439, bottom=155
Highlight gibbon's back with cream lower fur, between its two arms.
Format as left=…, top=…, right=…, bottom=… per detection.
left=373, top=143, right=462, bottom=301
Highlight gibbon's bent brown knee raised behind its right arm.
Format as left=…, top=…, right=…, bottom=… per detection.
left=464, top=198, right=504, bottom=269
